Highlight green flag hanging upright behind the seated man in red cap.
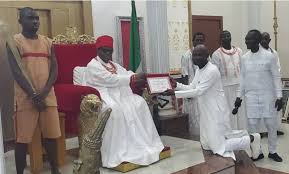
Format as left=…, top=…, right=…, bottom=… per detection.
left=129, top=0, right=141, bottom=72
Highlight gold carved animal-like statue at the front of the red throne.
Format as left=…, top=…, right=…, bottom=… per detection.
left=73, top=94, right=111, bottom=174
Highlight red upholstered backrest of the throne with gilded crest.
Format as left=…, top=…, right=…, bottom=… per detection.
left=54, top=44, right=97, bottom=84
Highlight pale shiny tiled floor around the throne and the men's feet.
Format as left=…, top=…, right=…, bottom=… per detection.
left=5, top=124, right=289, bottom=174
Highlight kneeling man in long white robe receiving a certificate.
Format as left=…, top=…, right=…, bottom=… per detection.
left=165, top=45, right=260, bottom=159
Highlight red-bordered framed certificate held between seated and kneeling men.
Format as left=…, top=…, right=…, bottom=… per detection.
left=147, top=75, right=172, bottom=94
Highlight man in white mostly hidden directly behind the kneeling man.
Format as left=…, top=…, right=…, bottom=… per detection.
left=181, top=32, right=205, bottom=135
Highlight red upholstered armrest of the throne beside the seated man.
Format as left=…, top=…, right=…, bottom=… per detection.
left=54, top=84, right=101, bottom=113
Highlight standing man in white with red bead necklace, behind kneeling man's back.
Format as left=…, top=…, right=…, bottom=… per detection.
left=211, top=30, right=247, bottom=129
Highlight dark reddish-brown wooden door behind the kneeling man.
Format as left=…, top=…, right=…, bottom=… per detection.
left=192, top=15, right=223, bottom=54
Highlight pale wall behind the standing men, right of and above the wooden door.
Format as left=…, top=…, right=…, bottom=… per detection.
left=191, top=0, right=289, bottom=78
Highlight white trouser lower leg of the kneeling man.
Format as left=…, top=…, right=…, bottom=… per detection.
left=225, top=135, right=250, bottom=151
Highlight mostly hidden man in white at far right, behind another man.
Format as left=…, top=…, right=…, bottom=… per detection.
left=260, top=32, right=284, bottom=135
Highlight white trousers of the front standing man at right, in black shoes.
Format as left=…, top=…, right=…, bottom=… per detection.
left=248, top=117, right=279, bottom=153
